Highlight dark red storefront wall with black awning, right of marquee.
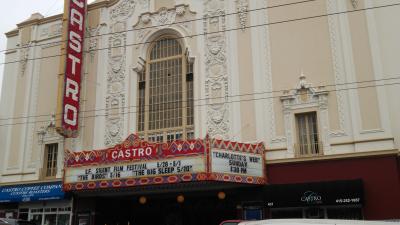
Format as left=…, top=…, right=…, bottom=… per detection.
left=266, top=154, right=400, bottom=220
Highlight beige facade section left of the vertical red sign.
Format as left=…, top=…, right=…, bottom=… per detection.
left=0, top=14, right=63, bottom=183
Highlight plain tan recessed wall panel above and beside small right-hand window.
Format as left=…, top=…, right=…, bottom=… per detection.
left=268, top=1, right=339, bottom=142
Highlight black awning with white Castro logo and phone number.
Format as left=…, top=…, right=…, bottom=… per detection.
left=264, top=180, right=364, bottom=219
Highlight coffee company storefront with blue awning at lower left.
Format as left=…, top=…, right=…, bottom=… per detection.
left=0, top=182, right=72, bottom=225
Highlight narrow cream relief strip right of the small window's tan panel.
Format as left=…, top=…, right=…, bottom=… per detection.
left=327, top=0, right=346, bottom=137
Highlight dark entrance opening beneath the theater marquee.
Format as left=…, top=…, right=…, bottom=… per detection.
left=95, top=194, right=237, bottom=225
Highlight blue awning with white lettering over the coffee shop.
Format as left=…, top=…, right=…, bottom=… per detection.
left=0, top=182, right=64, bottom=203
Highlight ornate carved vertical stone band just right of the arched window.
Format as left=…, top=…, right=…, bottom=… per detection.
left=203, top=0, right=230, bottom=139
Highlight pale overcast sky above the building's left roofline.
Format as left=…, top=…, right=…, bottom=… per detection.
left=0, top=0, right=94, bottom=97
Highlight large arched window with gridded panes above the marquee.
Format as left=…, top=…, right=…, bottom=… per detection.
left=137, top=37, right=194, bottom=142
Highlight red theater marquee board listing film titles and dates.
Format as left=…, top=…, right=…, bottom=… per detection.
left=64, top=135, right=266, bottom=191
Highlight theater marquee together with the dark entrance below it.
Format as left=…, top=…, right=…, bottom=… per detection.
left=64, top=135, right=266, bottom=225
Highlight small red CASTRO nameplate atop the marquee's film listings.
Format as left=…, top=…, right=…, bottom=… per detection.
left=107, top=145, right=157, bottom=161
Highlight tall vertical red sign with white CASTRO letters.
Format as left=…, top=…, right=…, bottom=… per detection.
left=62, top=0, right=86, bottom=137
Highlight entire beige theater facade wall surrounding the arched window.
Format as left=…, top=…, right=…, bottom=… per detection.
left=0, top=0, right=400, bottom=182
